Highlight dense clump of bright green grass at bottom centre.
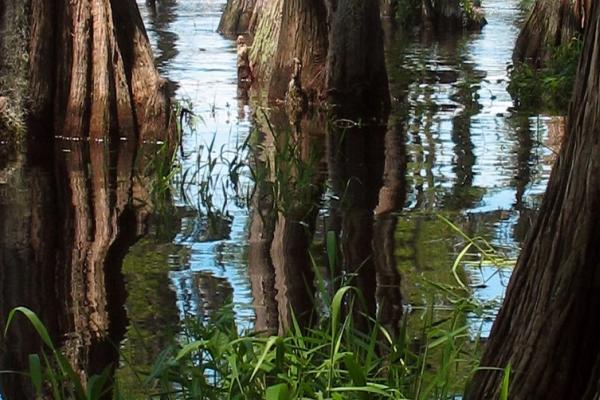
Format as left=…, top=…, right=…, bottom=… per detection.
left=116, top=287, right=482, bottom=399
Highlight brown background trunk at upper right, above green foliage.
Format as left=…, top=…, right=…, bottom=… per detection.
left=513, top=0, right=590, bottom=67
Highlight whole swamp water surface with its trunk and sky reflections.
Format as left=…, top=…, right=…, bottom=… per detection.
left=0, top=0, right=562, bottom=398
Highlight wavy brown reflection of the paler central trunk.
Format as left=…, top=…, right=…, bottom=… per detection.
left=248, top=110, right=324, bottom=333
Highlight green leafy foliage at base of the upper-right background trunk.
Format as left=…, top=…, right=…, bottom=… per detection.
left=508, top=38, right=583, bottom=114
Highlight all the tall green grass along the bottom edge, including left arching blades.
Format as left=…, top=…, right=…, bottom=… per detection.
left=6, top=216, right=511, bottom=400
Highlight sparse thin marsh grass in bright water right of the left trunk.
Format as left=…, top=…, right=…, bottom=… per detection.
left=145, top=99, right=250, bottom=241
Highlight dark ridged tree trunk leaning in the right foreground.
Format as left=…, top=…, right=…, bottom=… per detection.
left=468, top=2, right=600, bottom=400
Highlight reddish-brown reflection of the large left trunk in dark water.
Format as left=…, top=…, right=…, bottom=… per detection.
left=0, top=138, right=159, bottom=398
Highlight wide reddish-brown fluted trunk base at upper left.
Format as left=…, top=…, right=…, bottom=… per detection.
left=3, top=0, right=170, bottom=141
